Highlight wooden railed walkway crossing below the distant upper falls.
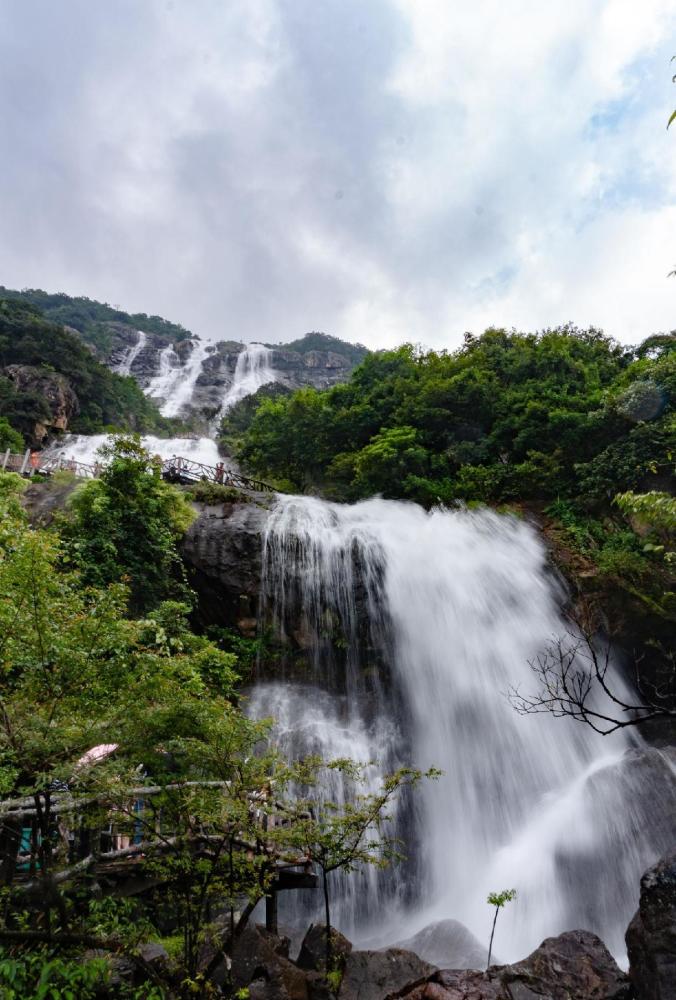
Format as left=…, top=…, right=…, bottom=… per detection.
left=0, top=449, right=276, bottom=493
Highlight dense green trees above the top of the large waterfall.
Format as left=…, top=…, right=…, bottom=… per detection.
left=239, top=327, right=676, bottom=504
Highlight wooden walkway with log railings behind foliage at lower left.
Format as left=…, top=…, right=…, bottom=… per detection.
left=0, top=772, right=319, bottom=934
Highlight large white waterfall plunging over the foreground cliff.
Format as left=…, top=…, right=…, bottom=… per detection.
left=251, top=497, right=676, bottom=961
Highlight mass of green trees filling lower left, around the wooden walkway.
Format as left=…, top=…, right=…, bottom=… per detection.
left=0, top=450, right=418, bottom=1000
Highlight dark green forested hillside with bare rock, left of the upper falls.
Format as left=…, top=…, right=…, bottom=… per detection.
left=0, top=298, right=168, bottom=449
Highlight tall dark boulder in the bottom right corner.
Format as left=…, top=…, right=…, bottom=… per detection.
left=626, top=851, right=676, bottom=1000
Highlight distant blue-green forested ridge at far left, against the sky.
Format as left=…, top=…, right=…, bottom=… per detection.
left=0, top=285, right=192, bottom=355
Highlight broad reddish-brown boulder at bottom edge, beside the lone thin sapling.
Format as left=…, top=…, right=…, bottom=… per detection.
left=390, top=931, right=632, bottom=1000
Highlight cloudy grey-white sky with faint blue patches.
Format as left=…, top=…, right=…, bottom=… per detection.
left=0, top=0, right=676, bottom=347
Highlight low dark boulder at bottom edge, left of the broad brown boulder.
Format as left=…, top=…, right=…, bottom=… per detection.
left=338, top=948, right=434, bottom=1000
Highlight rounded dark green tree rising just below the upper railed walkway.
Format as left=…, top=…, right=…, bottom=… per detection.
left=62, top=435, right=194, bottom=610
